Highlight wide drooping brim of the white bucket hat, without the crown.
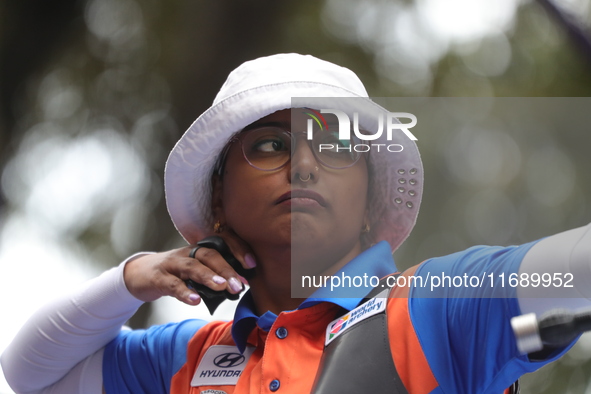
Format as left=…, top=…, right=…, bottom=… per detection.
left=164, top=81, right=423, bottom=250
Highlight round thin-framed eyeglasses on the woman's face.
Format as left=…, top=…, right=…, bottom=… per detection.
left=218, top=126, right=361, bottom=171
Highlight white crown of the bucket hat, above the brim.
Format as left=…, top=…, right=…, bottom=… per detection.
left=213, top=53, right=368, bottom=105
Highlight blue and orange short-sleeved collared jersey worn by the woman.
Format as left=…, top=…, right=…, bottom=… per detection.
left=103, top=242, right=566, bottom=394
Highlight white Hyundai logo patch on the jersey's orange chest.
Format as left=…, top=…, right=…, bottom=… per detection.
left=191, top=345, right=254, bottom=387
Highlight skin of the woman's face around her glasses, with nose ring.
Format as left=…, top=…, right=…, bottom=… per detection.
left=214, top=109, right=368, bottom=274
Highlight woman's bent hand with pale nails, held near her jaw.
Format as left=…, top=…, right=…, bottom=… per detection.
left=124, top=231, right=256, bottom=305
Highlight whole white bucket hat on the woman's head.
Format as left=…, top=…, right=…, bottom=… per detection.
left=164, top=53, right=423, bottom=251
